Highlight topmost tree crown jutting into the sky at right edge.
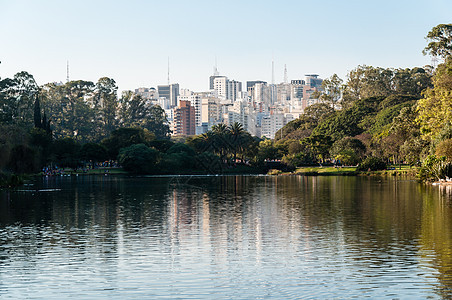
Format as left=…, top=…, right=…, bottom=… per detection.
left=422, top=24, right=452, bottom=59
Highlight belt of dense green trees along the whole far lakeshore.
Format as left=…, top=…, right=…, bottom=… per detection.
left=0, top=24, right=452, bottom=180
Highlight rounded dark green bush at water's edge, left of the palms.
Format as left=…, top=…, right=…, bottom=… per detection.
left=118, top=144, right=159, bottom=174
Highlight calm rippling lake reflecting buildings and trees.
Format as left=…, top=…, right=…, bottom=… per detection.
left=0, top=176, right=452, bottom=299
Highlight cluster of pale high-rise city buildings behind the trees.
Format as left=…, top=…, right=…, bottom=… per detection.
left=135, top=71, right=322, bottom=139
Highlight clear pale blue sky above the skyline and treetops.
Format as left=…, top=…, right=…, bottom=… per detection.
left=0, top=0, right=452, bottom=91
